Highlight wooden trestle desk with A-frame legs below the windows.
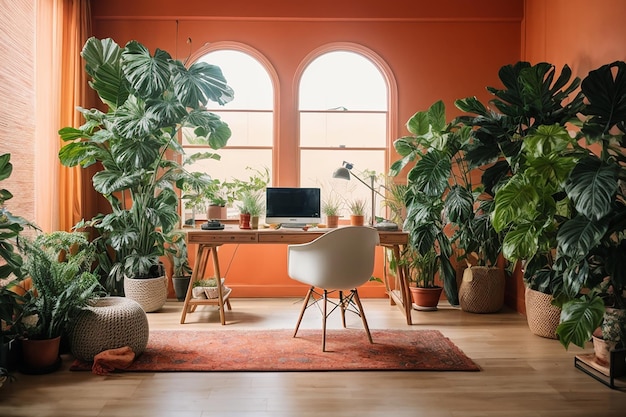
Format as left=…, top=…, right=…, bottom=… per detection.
left=180, top=225, right=412, bottom=324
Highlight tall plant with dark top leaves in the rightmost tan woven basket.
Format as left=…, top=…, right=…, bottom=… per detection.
left=455, top=62, right=583, bottom=322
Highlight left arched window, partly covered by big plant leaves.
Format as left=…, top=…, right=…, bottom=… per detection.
left=183, top=44, right=274, bottom=216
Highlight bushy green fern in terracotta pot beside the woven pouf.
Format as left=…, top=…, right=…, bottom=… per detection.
left=14, top=231, right=103, bottom=373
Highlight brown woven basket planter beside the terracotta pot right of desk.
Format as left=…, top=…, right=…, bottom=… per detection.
left=459, top=266, right=506, bottom=313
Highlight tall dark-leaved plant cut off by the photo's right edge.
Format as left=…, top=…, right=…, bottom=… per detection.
left=555, top=61, right=626, bottom=349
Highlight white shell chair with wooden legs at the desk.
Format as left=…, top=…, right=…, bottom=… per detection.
left=287, top=226, right=379, bottom=351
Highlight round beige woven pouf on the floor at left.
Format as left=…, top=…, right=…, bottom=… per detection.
left=70, top=297, right=149, bottom=361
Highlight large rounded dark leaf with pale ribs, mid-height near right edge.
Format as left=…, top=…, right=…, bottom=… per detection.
left=565, top=156, right=619, bottom=220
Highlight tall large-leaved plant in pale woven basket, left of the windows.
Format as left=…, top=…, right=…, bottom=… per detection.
left=59, top=38, right=233, bottom=302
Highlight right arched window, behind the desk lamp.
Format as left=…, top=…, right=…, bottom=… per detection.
left=299, top=48, right=389, bottom=221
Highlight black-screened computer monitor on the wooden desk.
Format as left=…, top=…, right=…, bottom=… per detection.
left=265, top=187, right=322, bottom=227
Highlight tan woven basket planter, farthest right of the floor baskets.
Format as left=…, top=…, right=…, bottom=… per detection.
left=525, top=288, right=561, bottom=339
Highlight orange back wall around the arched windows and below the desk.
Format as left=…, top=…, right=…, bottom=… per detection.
left=92, top=0, right=524, bottom=297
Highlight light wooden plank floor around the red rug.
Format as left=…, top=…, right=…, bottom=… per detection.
left=0, top=298, right=626, bottom=417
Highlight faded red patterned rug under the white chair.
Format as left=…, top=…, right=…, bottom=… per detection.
left=70, top=329, right=480, bottom=372
